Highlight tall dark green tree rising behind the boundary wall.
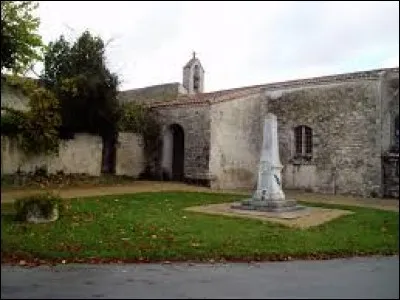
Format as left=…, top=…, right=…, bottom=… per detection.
left=43, top=31, right=118, bottom=136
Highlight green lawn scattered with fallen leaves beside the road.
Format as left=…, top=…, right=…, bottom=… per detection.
left=1, top=192, right=399, bottom=262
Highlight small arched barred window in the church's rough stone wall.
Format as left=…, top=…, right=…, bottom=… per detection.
left=293, top=125, right=314, bottom=160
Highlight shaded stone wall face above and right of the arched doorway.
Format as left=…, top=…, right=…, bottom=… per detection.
left=157, top=105, right=210, bottom=180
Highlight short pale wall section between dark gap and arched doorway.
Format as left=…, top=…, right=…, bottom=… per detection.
left=115, top=132, right=146, bottom=177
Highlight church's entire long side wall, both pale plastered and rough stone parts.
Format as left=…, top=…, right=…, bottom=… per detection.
left=210, top=72, right=398, bottom=197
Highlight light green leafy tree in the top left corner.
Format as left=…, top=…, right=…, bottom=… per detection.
left=1, top=1, right=43, bottom=74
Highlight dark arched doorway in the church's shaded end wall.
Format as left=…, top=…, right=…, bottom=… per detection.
left=162, top=124, right=185, bottom=181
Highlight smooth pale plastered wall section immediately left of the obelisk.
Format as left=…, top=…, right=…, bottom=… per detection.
left=210, top=93, right=266, bottom=189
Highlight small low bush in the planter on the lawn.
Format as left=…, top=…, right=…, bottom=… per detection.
left=14, top=193, right=63, bottom=221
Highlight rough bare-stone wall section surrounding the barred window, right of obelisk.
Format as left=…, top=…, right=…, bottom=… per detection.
left=265, top=78, right=382, bottom=197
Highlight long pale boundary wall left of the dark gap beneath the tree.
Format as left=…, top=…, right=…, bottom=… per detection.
left=1, top=134, right=103, bottom=176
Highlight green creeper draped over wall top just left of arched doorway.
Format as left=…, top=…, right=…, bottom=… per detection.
left=118, top=103, right=161, bottom=153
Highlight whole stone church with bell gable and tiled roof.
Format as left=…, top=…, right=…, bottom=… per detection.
left=119, top=55, right=399, bottom=197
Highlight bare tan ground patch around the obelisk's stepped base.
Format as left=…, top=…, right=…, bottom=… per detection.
left=185, top=203, right=353, bottom=229
